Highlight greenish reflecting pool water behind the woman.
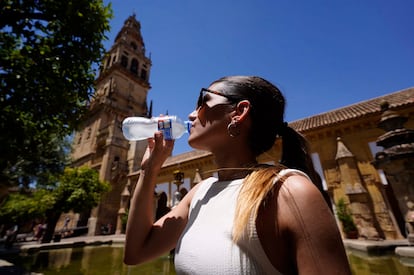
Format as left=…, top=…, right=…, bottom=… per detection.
left=2, top=245, right=414, bottom=275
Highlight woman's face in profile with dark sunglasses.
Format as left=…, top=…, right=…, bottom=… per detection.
left=188, top=83, right=234, bottom=152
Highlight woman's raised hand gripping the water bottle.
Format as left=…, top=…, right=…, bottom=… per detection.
left=141, top=131, right=174, bottom=170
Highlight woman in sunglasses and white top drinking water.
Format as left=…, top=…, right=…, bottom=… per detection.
left=124, top=76, right=350, bottom=274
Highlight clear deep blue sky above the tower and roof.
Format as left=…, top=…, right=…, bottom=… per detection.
left=105, top=0, right=414, bottom=155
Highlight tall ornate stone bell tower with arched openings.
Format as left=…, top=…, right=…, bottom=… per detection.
left=72, top=15, right=152, bottom=235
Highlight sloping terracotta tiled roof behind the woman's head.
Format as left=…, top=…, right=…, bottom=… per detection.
left=289, top=87, right=414, bottom=132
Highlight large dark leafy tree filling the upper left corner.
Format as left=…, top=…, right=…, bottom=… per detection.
left=0, top=0, right=112, bottom=187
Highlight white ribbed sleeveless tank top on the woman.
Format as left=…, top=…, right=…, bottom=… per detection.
left=175, top=169, right=307, bottom=275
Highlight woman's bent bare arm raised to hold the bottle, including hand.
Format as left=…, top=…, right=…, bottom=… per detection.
left=124, top=133, right=196, bottom=265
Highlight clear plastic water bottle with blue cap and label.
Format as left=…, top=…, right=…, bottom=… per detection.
left=122, top=116, right=191, bottom=141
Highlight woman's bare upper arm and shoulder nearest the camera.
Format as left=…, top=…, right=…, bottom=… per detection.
left=279, top=176, right=351, bottom=275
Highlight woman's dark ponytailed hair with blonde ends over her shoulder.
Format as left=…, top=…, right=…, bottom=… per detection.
left=213, top=76, right=323, bottom=241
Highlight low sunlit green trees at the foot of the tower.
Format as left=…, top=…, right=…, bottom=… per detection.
left=0, top=167, right=110, bottom=227
